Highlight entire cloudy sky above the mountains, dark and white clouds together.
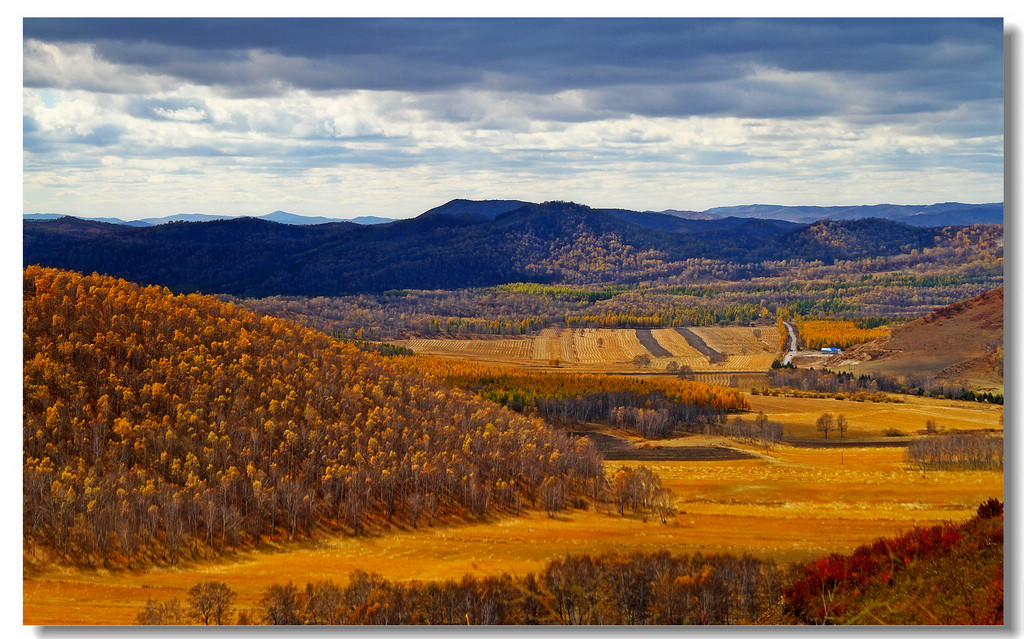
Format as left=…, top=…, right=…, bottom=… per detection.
left=23, top=18, right=1004, bottom=219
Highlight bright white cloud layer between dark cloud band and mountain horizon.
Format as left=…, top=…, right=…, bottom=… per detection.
left=23, top=43, right=1002, bottom=218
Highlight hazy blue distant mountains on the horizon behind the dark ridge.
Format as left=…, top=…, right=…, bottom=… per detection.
left=24, top=200, right=1002, bottom=230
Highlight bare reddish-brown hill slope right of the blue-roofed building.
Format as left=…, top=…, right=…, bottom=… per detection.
left=826, top=287, right=1002, bottom=387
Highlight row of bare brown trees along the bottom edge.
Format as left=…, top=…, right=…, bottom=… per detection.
left=136, top=552, right=783, bottom=626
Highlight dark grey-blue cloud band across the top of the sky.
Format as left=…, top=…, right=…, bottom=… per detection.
left=24, top=18, right=1002, bottom=115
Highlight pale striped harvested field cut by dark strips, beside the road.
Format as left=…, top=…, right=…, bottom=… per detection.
left=392, top=327, right=778, bottom=373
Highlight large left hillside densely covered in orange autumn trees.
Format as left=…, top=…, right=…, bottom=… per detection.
left=23, top=267, right=602, bottom=565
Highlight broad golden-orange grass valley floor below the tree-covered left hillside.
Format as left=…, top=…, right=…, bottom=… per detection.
left=24, top=395, right=1004, bottom=625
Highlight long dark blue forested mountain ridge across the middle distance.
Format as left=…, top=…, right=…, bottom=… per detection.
left=23, top=202, right=974, bottom=296
